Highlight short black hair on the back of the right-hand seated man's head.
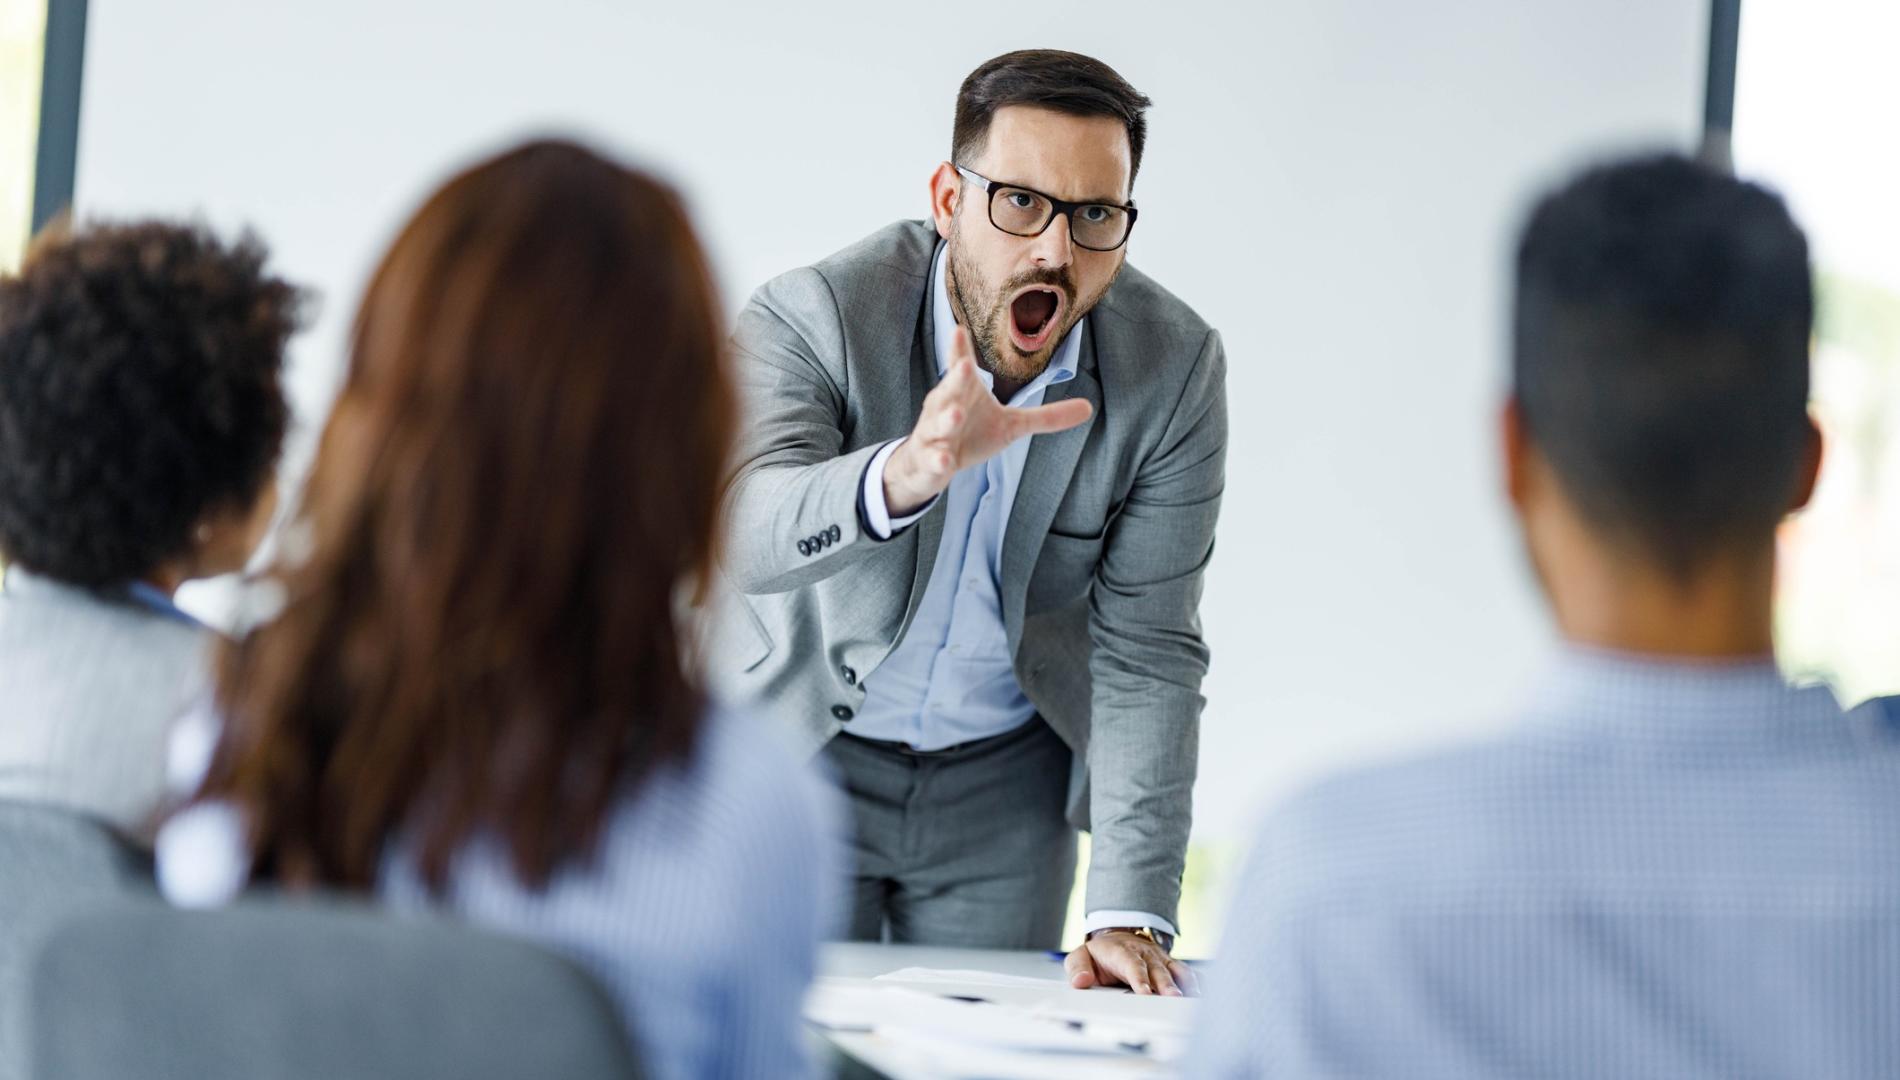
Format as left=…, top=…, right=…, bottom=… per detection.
left=1512, top=154, right=1815, bottom=578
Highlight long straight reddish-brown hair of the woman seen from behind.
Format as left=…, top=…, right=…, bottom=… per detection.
left=200, top=143, right=735, bottom=890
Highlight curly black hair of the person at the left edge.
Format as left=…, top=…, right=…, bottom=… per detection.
left=0, top=221, right=304, bottom=589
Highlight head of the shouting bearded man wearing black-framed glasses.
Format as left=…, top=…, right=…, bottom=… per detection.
left=931, top=49, right=1148, bottom=382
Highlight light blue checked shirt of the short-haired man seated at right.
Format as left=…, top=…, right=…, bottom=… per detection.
left=1186, top=650, right=1900, bottom=1080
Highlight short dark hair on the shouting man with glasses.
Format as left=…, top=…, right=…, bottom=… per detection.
left=950, top=49, right=1151, bottom=188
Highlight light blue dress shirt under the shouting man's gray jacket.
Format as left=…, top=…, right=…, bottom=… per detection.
left=851, top=243, right=1087, bottom=749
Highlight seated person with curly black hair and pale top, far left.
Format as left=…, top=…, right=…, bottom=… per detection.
left=0, top=222, right=302, bottom=839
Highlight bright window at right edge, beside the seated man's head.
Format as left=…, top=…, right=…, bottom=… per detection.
left=1735, top=0, right=1900, bottom=704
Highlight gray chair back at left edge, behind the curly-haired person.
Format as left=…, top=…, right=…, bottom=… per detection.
left=0, top=800, right=152, bottom=1080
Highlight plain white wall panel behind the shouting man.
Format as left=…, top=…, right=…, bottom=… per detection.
left=78, top=0, right=1706, bottom=842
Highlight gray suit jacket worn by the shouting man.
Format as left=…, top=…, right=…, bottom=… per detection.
left=711, top=221, right=1227, bottom=920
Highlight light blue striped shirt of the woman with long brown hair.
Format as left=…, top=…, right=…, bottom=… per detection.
left=158, top=699, right=847, bottom=1080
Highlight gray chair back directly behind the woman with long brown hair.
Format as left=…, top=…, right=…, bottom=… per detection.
left=25, top=899, right=640, bottom=1080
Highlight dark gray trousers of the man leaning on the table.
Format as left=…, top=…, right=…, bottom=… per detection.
left=825, top=717, right=1075, bottom=949
